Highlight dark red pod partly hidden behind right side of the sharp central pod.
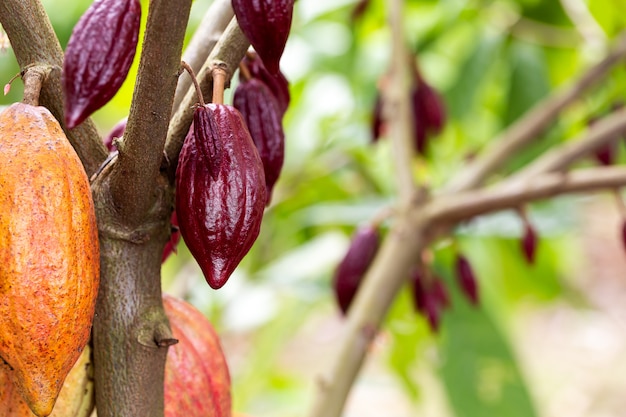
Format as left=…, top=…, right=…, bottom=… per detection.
left=233, top=78, right=285, bottom=204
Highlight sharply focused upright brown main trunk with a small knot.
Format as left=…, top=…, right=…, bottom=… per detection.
left=92, top=0, right=192, bottom=417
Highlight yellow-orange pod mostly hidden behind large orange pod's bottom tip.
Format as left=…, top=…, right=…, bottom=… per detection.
left=0, top=345, right=95, bottom=417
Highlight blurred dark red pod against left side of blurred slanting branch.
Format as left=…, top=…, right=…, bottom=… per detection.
left=333, top=225, right=380, bottom=314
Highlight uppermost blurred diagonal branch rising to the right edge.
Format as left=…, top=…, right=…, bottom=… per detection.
left=444, top=32, right=626, bottom=193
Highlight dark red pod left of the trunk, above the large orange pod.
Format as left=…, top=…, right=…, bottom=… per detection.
left=63, top=0, right=141, bottom=129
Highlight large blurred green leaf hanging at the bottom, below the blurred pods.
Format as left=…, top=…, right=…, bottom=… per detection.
left=440, top=264, right=537, bottom=417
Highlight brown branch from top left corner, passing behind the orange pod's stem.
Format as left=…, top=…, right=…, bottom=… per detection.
left=0, top=0, right=108, bottom=176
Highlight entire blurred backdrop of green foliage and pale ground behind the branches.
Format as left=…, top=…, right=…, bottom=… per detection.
left=0, top=0, right=626, bottom=417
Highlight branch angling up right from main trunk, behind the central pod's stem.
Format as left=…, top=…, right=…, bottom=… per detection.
left=165, top=18, right=250, bottom=178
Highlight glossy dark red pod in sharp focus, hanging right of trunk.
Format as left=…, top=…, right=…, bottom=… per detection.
left=176, top=104, right=267, bottom=289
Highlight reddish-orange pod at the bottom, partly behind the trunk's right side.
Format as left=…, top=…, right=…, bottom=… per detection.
left=163, top=295, right=231, bottom=417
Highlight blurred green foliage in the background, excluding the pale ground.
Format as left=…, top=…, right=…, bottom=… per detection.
left=0, top=0, right=626, bottom=417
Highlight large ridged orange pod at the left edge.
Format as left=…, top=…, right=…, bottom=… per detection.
left=0, top=103, right=100, bottom=416
